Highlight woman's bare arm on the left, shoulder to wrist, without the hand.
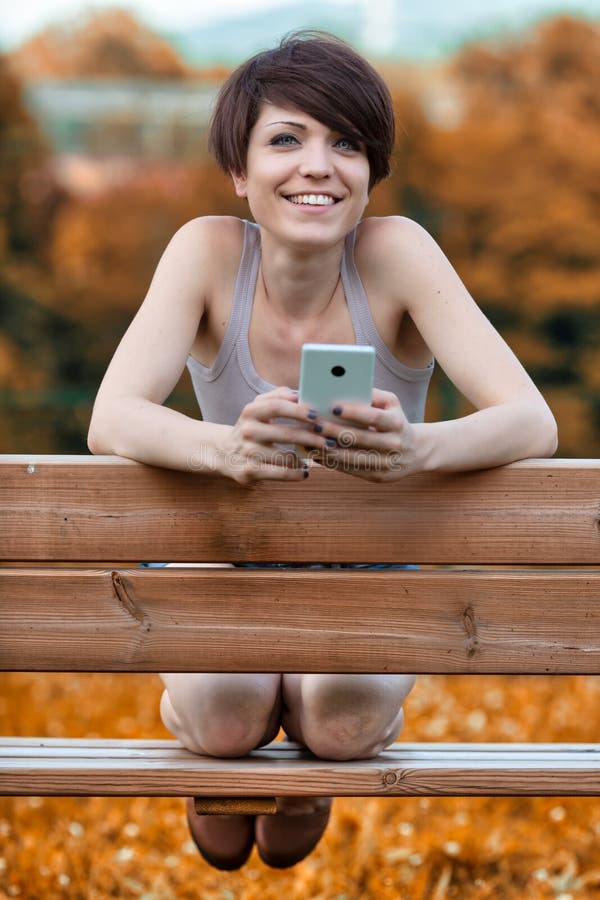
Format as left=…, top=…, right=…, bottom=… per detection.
left=88, top=219, right=231, bottom=469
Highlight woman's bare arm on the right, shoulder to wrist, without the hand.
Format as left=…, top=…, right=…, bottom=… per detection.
left=400, top=220, right=557, bottom=470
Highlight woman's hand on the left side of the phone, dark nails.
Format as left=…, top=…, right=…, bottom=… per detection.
left=219, top=387, right=327, bottom=484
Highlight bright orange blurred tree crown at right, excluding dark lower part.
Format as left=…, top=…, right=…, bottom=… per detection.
left=415, top=17, right=600, bottom=316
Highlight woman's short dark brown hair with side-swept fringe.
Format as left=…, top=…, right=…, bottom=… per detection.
left=209, top=30, right=395, bottom=189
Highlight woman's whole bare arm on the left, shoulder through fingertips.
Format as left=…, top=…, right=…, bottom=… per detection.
left=88, top=218, right=332, bottom=483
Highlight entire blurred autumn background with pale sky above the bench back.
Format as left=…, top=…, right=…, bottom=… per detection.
left=0, top=0, right=600, bottom=457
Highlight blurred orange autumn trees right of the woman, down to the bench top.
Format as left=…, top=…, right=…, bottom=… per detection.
left=394, top=17, right=600, bottom=456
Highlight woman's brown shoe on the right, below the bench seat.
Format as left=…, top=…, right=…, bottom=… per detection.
left=255, top=797, right=331, bottom=869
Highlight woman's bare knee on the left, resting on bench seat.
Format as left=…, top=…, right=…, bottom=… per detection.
left=161, top=673, right=281, bottom=757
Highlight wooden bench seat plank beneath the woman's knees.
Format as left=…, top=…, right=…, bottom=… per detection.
left=0, top=738, right=600, bottom=797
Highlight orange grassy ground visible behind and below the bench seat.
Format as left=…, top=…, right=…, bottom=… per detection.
left=0, top=673, right=600, bottom=900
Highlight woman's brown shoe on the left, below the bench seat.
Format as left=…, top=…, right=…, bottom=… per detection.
left=186, top=797, right=255, bottom=872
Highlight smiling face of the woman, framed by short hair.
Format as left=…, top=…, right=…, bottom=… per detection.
left=232, top=103, right=369, bottom=246
